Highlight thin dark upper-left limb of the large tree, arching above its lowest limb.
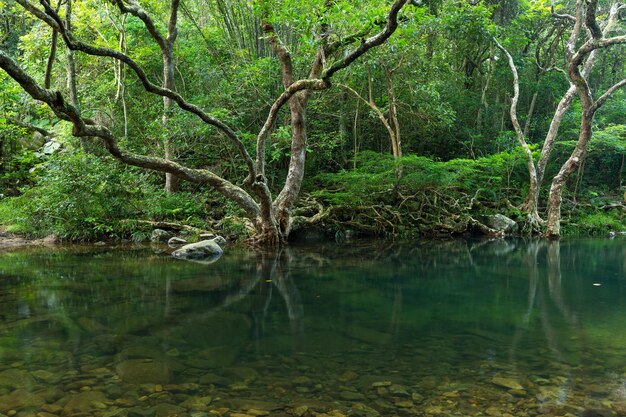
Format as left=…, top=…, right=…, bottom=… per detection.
left=21, top=0, right=255, bottom=176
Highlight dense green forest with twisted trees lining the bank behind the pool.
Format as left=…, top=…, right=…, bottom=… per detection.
left=0, top=0, right=626, bottom=246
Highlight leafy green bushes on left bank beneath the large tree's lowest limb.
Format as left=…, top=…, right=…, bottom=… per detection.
left=0, top=151, right=212, bottom=240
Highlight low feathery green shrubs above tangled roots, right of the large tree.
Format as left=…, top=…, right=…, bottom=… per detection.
left=314, top=148, right=525, bottom=206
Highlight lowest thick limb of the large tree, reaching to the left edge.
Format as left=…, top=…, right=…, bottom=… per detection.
left=0, top=50, right=259, bottom=221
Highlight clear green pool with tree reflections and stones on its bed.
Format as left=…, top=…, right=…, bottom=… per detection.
left=0, top=239, right=626, bottom=417
